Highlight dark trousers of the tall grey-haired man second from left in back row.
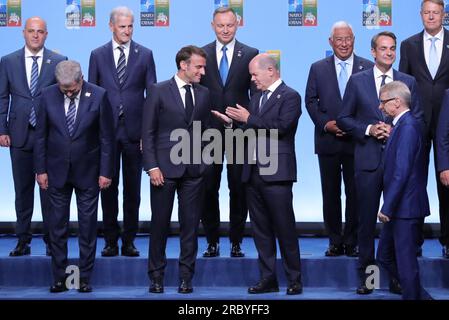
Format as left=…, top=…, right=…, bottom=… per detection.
left=101, top=117, right=142, bottom=244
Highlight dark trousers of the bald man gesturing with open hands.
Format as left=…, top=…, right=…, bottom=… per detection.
left=246, top=165, right=301, bottom=282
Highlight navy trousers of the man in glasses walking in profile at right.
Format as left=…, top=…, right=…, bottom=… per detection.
left=377, top=218, right=430, bottom=300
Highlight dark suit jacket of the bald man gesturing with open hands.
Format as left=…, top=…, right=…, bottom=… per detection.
left=242, top=82, right=301, bottom=182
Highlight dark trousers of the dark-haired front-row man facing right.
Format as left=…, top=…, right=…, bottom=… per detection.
left=148, top=174, right=204, bottom=280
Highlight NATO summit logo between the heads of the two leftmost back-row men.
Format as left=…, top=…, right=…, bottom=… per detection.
left=65, top=0, right=95, bottom=29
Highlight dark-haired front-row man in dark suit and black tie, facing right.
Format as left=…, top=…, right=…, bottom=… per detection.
left=142, top=46, right=211, bottom=293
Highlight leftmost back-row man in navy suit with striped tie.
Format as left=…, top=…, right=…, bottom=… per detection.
left=0, top=17, right=67, bottom=256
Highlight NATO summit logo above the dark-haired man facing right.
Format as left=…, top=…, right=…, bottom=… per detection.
left=140, top=0, right=170, bottom=27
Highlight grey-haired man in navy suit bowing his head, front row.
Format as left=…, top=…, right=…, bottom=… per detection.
left=34, top=61, right=113, bottom=292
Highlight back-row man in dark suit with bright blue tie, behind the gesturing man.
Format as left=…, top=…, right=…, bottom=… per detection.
left=201, top=7, right=259, bottom=257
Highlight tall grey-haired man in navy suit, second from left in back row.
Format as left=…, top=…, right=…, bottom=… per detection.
left=89, top=7, right=156, bottom=257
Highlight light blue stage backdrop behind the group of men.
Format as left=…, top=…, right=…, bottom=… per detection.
left=0, top=0, right=439, bottom=222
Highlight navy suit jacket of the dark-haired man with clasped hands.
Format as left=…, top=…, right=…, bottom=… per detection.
left=337, top=68, right=423, bottom=171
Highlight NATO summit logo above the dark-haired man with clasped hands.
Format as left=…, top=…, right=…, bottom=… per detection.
left=362, top=0, right=392, bottom=29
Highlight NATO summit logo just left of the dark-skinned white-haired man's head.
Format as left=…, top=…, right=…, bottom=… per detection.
left=288, top=0, right=318, bottom=27
